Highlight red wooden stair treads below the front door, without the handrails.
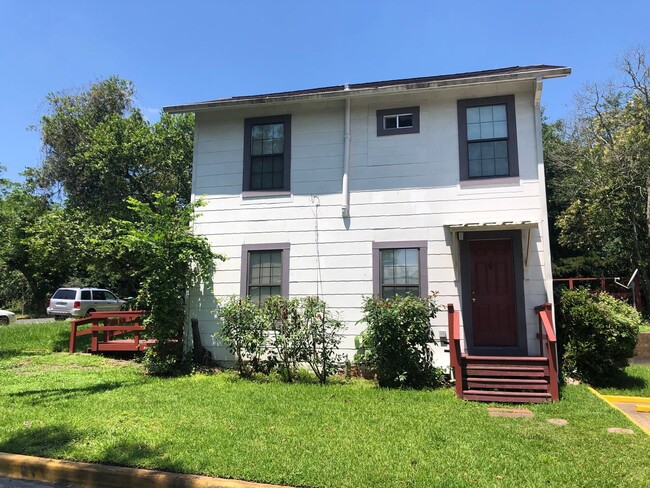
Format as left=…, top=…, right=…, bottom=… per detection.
left=457, top=354, right=552, bottom=403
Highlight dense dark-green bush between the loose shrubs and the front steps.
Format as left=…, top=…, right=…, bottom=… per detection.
left=355, top=294, right=444, bottom=388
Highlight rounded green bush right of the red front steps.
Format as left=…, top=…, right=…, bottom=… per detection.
left=558, top=289, right=643, bottom=384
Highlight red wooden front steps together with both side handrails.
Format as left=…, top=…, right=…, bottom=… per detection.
left=447, top=304, right=560, bottom=403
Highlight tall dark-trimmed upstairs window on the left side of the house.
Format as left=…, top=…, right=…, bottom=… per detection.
left=243, top=115, right=291, bottom=192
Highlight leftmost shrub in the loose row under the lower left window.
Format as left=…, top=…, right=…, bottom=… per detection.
left=217, top=296, right=266, bottom=377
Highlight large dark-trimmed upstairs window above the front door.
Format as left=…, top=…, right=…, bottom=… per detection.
left=458, top=95, right=519, bottom=180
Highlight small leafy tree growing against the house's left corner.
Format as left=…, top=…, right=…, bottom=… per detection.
left=113, top=193, right=223, bottom=374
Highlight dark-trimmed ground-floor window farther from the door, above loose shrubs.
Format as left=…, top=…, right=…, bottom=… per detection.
left=241, top=243, right=289, bottom=305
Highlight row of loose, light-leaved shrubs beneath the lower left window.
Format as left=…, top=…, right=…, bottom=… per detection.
left=215, top=296, right=343, bottom=384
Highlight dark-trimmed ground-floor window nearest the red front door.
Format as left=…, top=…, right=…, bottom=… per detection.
left=372, top=241, right=428, bottom=298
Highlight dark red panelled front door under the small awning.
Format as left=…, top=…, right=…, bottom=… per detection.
left=469, top=239, right=517, bottom=347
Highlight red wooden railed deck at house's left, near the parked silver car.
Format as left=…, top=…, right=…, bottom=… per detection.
left=69, top=310, right=147, bottom=353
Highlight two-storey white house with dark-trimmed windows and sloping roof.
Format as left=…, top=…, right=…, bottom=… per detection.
left=165, top=65, right=570, bottom=400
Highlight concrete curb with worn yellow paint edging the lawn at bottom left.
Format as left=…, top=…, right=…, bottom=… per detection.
left=0, top=452, right=281, bottom=488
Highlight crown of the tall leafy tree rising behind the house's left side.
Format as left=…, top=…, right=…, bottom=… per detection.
left=29, top=76, right=194, bottom=221
